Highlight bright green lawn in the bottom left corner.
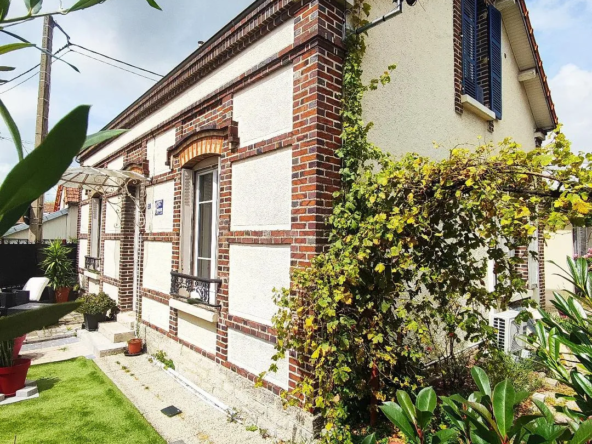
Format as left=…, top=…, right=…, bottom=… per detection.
left=0, top=358, right=165, bottom=444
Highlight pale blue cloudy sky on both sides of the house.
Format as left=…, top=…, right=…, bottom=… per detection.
left=0, top=0, right=592, bottom=200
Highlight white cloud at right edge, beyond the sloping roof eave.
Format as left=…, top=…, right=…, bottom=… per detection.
left=550, top=64, right=592, bottom=152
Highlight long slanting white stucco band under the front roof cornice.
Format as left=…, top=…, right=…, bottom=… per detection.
left=84, top=20, right=294, bottom=165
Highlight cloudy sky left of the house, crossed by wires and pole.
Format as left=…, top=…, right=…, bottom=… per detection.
left=0, top=0, right=252, bottom=200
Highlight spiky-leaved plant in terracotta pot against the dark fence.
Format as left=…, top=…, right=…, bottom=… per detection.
left=41, top=240, right=76, bottom=303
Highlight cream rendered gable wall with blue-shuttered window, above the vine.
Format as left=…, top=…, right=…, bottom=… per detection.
left=363, top=0, right=563, bottom=306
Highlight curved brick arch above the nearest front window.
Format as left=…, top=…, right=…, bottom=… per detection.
left=168, top=129, right=228, bottom=168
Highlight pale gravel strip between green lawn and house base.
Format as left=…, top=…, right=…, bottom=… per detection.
left=95, top=355, right=276, bottom=444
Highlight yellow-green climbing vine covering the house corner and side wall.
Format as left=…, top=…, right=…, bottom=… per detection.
left=271, top=1, right=592, bottom=443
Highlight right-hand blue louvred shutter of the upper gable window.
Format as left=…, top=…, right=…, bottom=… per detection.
left=488, top=6, right=502, bottom=119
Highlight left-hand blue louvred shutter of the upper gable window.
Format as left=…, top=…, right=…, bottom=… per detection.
left=462, top=0, right=477, bottom=99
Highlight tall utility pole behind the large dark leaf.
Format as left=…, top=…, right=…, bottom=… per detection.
left=29, top=16, right=54, bottom=244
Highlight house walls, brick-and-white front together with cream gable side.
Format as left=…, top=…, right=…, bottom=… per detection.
left=68, top=0, right=554, bottom=437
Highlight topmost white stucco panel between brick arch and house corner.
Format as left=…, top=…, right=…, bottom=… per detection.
left=233, top=65, right=294, bottom=146
